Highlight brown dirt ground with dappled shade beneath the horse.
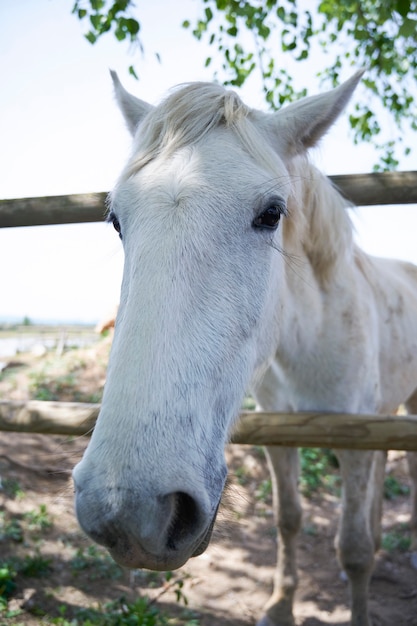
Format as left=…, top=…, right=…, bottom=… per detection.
left=0, top=338, right=417, bottom=626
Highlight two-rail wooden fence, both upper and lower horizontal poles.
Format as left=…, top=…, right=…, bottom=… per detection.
left=0, top=171, right=417, bottom=451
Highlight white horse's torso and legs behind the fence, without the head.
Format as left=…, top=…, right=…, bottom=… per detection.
left=254, top=218, right=417, bottom=626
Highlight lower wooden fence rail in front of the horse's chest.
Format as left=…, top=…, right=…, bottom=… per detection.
left=0, top=400, right=417, bottom=451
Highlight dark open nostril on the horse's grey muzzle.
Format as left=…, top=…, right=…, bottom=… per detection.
left=166, top=491, right=201, bottom=550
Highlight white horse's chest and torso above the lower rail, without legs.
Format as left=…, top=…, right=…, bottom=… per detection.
left=270, top=248, right=417, bottom=413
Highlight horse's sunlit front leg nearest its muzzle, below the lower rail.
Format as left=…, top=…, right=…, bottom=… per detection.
left=257, top=446, right=301, bottom=626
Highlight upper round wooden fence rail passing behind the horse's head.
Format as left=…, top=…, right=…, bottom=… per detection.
left=0, top=171, right=417, bottom=228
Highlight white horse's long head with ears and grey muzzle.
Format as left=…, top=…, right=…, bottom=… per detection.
left=74, top=73, right=362, bottom=570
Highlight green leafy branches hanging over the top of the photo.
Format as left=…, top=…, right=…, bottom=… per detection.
left=73, top=0, right=417, bottom=170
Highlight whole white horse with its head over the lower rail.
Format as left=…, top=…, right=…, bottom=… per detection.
left=74, top=73, right=417, bottom=626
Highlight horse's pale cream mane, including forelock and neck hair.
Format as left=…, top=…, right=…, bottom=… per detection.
left=122, top=82, right=353, bottom=286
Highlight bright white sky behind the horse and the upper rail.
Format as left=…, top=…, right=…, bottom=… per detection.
left=0, top=0, right=417, bottom=323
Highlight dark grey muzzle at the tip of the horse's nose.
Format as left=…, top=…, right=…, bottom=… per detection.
left=74, top=468, right=220, bottom=571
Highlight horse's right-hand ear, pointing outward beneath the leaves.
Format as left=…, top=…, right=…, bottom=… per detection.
left=269, top=70, right=365, bottom=157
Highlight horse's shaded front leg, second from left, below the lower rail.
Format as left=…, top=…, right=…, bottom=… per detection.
left=336, top=450, right=378, bottom=626
